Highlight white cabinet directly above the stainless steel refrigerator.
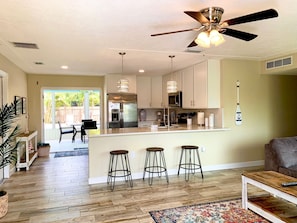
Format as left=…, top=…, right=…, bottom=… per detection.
left=105, top=74, right=136, bottom=93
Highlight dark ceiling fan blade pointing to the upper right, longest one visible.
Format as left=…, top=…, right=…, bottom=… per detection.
left=221, top=9, right=278, bottom=27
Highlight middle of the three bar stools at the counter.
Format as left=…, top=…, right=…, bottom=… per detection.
left=143, top=147, right=169, bottom=185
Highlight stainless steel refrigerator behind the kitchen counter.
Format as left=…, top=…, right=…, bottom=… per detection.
left=107, top=93, right=138, bottom=128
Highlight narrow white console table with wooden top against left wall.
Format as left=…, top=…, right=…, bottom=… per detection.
left=16, top=131, right=38, bottom=171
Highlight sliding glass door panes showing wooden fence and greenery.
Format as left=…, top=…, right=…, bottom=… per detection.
left=43, top=89, right=101, bottom=142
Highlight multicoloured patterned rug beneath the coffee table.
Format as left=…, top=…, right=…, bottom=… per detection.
left=149, top=199, right=269, bottom=223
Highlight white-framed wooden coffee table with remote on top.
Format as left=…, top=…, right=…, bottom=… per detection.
left=242, top=171, right=297, bottom=223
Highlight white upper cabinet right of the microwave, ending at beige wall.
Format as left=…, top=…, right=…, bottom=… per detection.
left=183, top=60, right=220, bottom=108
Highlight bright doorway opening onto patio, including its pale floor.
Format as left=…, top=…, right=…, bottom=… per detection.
left=42, top=89, right=101, bottom=152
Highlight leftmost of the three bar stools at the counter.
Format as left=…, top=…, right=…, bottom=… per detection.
left=107, top=150, right=133, bottom=191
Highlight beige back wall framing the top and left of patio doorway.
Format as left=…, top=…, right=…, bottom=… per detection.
left=28, top=74, right=104, bottom=140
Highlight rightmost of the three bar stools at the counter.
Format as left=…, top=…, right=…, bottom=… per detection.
left=177, top=145, right=203, bottom=181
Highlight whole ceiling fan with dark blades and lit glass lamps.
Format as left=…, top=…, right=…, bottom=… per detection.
left=151, top=7, right=278, bottom=47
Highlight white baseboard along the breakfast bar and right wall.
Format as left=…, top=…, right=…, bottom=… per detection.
left=89, top=160, right=264, bottom=184
